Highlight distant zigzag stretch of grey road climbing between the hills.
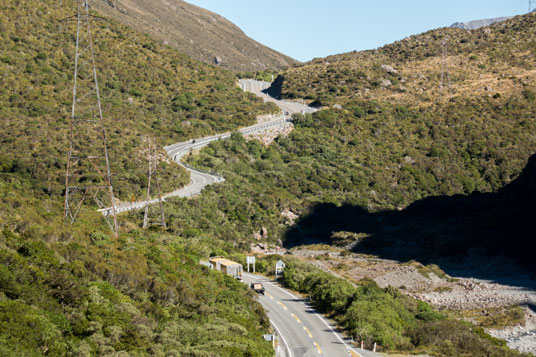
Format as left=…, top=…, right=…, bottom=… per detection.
left=99, top=79, right=315, bottom=216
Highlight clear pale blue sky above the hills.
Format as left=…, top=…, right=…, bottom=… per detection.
left=186, top=0, right=536, bottom=61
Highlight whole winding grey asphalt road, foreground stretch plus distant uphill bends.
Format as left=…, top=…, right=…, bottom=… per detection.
left=101, top=80, right=379, bottom=357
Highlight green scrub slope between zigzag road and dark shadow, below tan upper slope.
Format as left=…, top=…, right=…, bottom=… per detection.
left=184, top=88, right=536, bottom=248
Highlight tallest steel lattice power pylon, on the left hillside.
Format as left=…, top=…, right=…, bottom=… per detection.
left=62, top=0, right=118, bottom=237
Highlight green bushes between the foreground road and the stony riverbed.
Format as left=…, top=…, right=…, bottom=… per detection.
left=276, top=258, right=520, bottom=356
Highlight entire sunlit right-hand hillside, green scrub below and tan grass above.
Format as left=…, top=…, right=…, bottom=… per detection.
left=180, top=14, right=536, bottom=262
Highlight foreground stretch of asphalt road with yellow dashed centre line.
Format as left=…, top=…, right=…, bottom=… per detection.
left=243, top=273, right=380, bottom=357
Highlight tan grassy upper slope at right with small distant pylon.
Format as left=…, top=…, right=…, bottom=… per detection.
left=272, top=13, right=536, bottom=106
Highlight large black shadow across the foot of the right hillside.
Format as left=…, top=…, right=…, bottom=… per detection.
left=285, top=155, right=536, bottom=288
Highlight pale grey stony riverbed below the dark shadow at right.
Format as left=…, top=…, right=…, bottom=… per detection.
left=290, top=246, right=536, bottom=354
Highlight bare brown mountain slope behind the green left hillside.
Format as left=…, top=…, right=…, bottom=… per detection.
left=93, top=0, right=298, bottom=72
